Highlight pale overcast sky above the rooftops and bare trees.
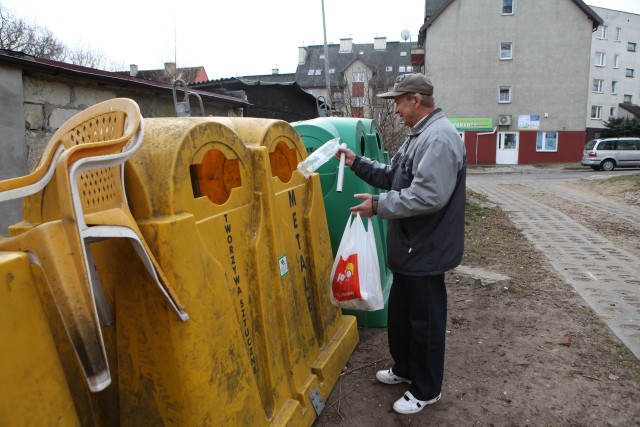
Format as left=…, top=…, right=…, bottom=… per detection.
left=0, top=0, right=640, bottom=79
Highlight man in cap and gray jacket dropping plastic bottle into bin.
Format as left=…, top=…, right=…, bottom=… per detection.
left=336, top=74, right=466, bottom=414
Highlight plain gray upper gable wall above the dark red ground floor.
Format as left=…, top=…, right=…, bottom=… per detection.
left=425, top=0, right=592, bottom=131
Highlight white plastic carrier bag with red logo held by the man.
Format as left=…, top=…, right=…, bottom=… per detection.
left=331, top=214, right=384, bottom=311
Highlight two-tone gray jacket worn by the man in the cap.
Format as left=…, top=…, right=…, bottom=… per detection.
left=351, top=109, right=467, bottom=276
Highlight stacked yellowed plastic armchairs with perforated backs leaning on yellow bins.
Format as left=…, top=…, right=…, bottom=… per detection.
left=0, top=98, right=188, bottom=392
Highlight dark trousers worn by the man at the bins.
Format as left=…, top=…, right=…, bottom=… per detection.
left=387, top=273, right=447, bottom=400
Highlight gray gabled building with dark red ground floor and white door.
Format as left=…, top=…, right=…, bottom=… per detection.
left=420, top=0, right=603, bottom=164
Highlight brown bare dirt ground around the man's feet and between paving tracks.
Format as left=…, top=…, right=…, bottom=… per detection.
left=314, top=172, right=640, bottom=426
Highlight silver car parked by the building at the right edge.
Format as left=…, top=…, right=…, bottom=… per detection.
left=580, top=138, right=640, bottom=171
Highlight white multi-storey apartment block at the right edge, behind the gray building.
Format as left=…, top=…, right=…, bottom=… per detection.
left=586, top=7, right=640, bottom=139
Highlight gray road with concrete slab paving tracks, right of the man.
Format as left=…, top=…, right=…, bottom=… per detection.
left=467, top=166, right=640, bottom=359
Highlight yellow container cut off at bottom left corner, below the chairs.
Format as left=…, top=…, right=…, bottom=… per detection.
left=0, top=252, right=81, bottom=427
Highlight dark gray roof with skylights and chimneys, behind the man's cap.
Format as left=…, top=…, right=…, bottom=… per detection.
left=295, top=41, right=417, bottom=88
